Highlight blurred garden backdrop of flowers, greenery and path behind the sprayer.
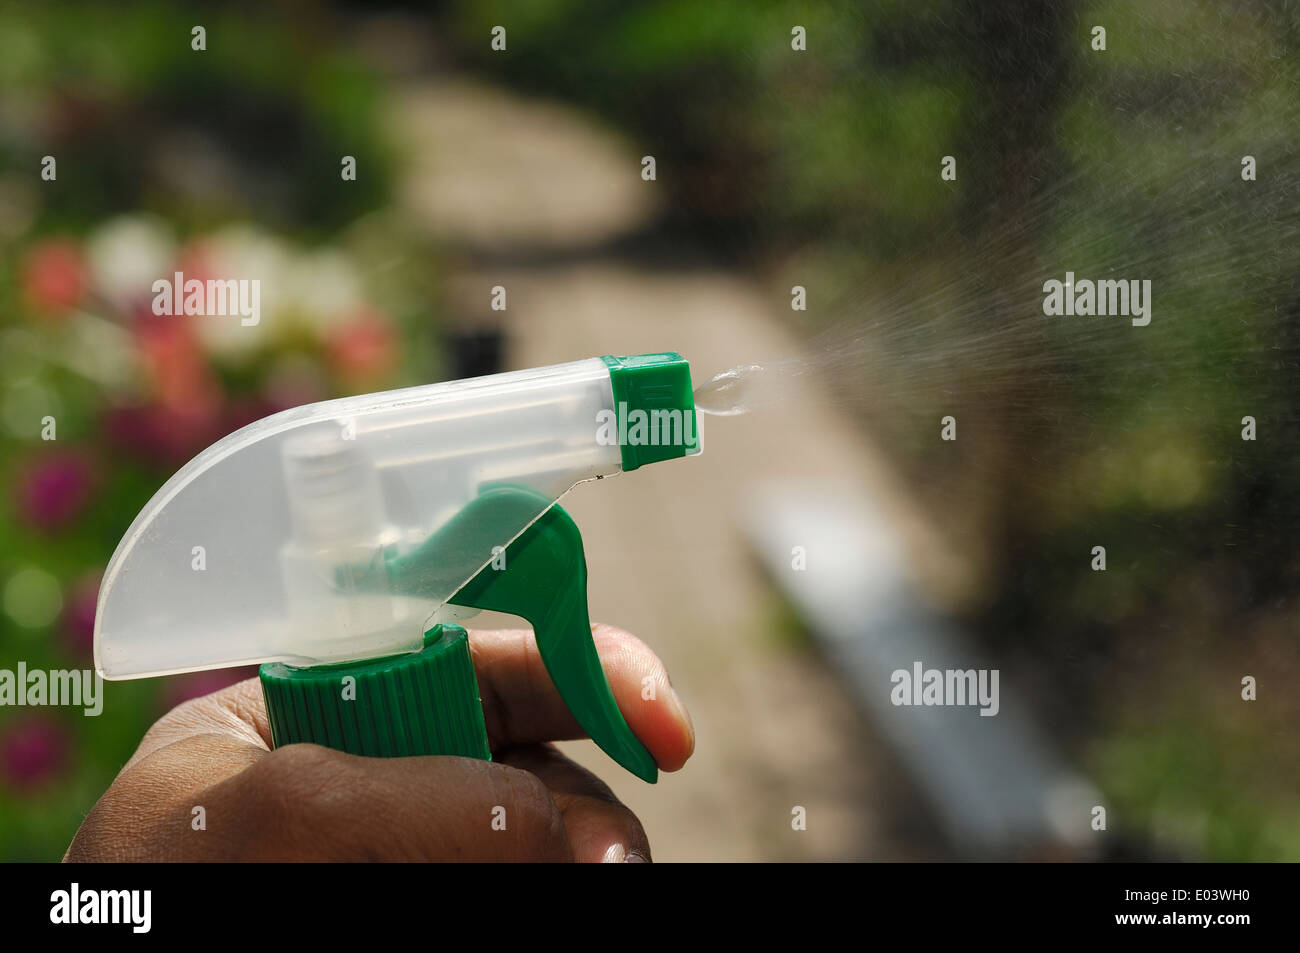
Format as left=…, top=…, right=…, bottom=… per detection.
left=0, top=0, right=1300, bottom=861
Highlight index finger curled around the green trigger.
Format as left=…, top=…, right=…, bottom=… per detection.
left=469, top=625, right=696, bottom=771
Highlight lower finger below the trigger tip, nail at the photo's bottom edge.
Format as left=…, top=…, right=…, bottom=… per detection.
left=499, top=745, right=650, bottom=862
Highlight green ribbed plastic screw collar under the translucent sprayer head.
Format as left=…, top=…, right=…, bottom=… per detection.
left=257, top=625, right=491, bottom=761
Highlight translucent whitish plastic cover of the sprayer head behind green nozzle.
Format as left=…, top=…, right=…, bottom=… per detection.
left=95, top=358, right=620, bottom=679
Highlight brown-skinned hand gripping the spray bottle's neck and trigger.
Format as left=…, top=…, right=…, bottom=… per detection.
left=64, top=625, right=694, bottom=861
